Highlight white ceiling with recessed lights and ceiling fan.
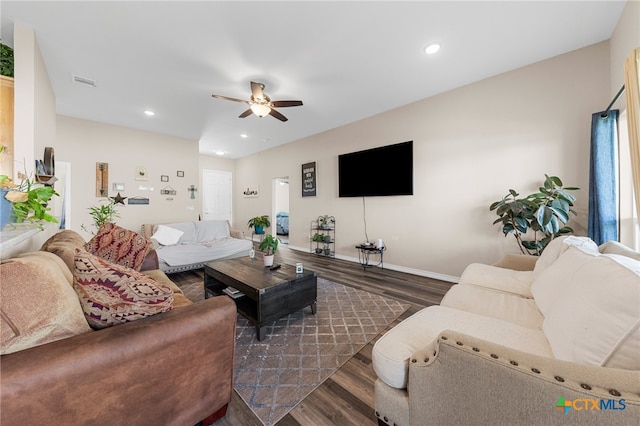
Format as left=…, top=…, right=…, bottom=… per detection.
left=1, top=0, right=625, bottom=158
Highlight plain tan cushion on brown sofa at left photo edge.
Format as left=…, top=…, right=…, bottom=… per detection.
left=0, top=251, right=91, bottom=355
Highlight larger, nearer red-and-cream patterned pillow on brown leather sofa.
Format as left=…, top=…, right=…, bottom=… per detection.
left=73, top=249, right=173, bottom=329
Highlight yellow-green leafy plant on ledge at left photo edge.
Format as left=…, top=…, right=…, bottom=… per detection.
left=0, top=173, right=58, bottom=229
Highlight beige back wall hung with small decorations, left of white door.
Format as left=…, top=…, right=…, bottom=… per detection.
left=56, top=116, right=200, bottom=237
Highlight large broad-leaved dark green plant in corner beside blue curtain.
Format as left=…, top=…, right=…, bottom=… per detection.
left=489, top=174, right=580, bottom=256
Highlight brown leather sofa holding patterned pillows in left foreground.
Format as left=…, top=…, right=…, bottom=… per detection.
left=0, top=231, right=236, bottom=426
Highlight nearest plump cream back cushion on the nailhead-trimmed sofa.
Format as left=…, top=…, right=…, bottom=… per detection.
left=532, top=247, right=640, bottom=370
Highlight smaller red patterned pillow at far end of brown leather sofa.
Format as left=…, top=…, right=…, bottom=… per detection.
left=85, top=223, right=151, bottom=271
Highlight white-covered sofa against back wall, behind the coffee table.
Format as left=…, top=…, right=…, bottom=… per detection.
left=142, top=220, right=253, bottom=274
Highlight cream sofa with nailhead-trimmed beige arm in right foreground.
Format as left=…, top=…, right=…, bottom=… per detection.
left=372, top=237, right=640, bottom=426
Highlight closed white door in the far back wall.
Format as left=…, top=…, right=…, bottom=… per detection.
left=202, top=170, right=232, bottom=223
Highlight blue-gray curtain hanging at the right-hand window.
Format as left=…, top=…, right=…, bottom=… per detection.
left=588, top=109, right=618, bottom=244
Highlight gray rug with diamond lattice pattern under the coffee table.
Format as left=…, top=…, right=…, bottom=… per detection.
left=176, top=278, right=409, bottom=426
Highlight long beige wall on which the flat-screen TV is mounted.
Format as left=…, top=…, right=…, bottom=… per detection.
left=236, top=42, right=609, bottom=278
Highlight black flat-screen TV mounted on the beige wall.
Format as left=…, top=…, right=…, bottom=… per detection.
left=338, top=141, right=413, bottom=197
